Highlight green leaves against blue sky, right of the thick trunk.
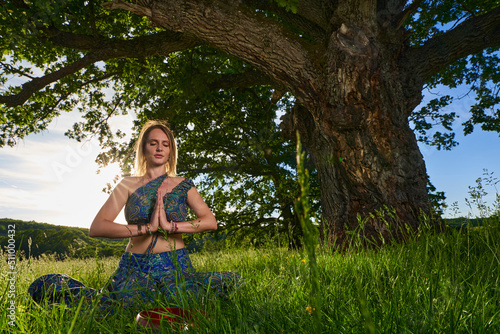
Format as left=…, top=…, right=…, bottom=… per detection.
left=407, top=0, right=500, bottom=145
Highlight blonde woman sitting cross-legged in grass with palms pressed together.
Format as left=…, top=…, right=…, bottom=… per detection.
left=28, top=121, right=241, bottom=314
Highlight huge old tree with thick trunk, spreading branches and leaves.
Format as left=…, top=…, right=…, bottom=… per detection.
left=0, top=0, right=500, bottom=242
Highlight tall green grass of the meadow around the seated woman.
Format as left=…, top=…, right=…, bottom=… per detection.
left=0, top=215, right=500, bottom=333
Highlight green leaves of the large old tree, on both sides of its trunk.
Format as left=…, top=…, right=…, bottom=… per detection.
left=0, top=0, right=500, bottom=153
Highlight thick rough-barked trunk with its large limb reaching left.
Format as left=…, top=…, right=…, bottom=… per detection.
left=105, top=0, right=429, bottom=248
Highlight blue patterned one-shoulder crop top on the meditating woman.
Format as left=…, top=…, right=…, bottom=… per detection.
left=125, top=174, right=194, bottom=225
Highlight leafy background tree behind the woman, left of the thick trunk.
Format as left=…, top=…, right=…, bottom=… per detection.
left=93, top=47, right=319, bottom=247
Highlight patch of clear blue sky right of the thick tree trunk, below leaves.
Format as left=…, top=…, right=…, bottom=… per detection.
left=417, top=83, right=500, bottom=217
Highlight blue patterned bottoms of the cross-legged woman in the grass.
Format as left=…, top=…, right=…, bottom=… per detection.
left=28, top=248, right=242, bottom=311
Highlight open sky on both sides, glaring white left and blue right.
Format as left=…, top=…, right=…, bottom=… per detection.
left=0, top=90, right=500, bottom=228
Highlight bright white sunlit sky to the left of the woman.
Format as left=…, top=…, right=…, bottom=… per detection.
left=0, top=109, right=132, bottom=227
